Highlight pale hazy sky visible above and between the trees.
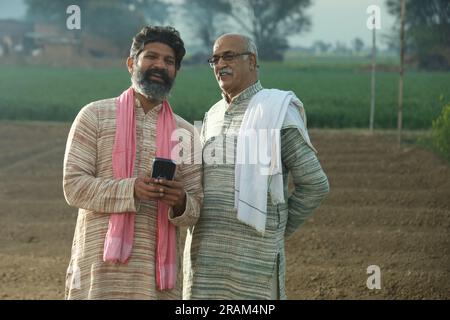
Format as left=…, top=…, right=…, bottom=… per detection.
left=0, top=0, right=394, bottom=46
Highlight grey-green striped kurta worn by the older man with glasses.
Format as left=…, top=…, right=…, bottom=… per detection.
left=183, top=82, right=329, bottom=299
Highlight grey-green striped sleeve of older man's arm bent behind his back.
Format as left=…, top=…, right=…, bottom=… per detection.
left=281, top=128, right=329, bottom=237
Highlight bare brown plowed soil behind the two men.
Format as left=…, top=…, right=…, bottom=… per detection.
left=0, top=122, right=450, bottom=299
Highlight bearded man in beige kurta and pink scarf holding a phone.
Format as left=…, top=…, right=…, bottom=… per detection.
left=63, top=26, right=203, bottom=299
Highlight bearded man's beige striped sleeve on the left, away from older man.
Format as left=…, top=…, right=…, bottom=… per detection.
left=63, top=104, right=136, bottom=213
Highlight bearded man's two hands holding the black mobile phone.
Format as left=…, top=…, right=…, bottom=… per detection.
left=134, top=177, right=186, bottom=216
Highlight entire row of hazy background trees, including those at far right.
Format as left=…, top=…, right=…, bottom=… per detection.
left=25, top=0, right=450, bottom=69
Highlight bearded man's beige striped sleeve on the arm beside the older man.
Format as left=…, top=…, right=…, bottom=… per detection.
left=169, top=122, right=203, bottom=227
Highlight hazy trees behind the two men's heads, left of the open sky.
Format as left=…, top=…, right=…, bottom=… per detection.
left=26, top=0, right=311, bottom=60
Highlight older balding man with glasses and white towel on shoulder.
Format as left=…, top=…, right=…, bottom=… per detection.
left=183, top=34, right=329, bottom=299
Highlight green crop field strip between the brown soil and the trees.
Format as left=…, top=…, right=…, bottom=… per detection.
left=0, top=57, right=450, bottom=129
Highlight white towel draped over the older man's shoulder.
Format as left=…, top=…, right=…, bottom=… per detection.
left=234, top=89, right=295, bottom=233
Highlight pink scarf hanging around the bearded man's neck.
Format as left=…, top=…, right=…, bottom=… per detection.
left=103, top=88, right=177, bottom=290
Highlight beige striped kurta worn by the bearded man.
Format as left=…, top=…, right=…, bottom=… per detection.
left=63, top=98, right=203, bottom=299
